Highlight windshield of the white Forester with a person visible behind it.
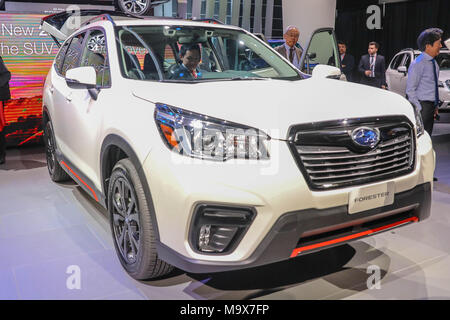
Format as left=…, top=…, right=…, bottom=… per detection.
left=117, top=26, right=302, bottom=82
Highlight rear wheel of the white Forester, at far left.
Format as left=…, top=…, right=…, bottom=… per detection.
left=44, top=121, right=70, bottom=182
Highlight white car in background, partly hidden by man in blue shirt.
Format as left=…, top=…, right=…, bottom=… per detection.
left=386, top=48, right=450, bottom=110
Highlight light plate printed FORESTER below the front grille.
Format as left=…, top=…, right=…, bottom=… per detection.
left=348, top=181, right=395, bottom=214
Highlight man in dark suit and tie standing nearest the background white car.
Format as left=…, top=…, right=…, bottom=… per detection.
left=358, top=41, right=387, bottom=89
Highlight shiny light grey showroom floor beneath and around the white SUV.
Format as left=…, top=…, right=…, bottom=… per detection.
left=0, top=114, right=450, bottom=299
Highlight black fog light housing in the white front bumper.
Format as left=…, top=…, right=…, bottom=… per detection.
left=189, top=205, right=256, bottom=254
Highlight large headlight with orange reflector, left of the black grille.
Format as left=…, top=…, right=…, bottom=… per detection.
left=155, top=103, right=270, bottom=161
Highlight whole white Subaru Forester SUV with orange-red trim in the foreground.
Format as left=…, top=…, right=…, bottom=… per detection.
left=42, top=11, right=435, bottom=279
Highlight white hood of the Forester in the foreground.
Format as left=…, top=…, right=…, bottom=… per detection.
left=131, top=78, right=415, bottom=139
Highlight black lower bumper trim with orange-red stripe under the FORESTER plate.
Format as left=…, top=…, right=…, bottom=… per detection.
left=157, top=183, right=432, bottom=273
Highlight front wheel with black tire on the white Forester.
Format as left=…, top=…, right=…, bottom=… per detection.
left=108, top=159, right=173, bottom=280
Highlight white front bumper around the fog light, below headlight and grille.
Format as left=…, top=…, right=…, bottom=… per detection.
left=143, top=133, right=435, bottom=272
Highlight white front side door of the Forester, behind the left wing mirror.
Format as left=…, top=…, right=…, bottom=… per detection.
left=65, top=27, right=113, bottom=189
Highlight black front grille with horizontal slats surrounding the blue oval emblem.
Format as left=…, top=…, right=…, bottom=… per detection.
left=289, top=117, right=415, bottom=190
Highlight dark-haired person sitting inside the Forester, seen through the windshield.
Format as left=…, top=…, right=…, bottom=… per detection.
left=169, top=43, right=202, bottom=80
